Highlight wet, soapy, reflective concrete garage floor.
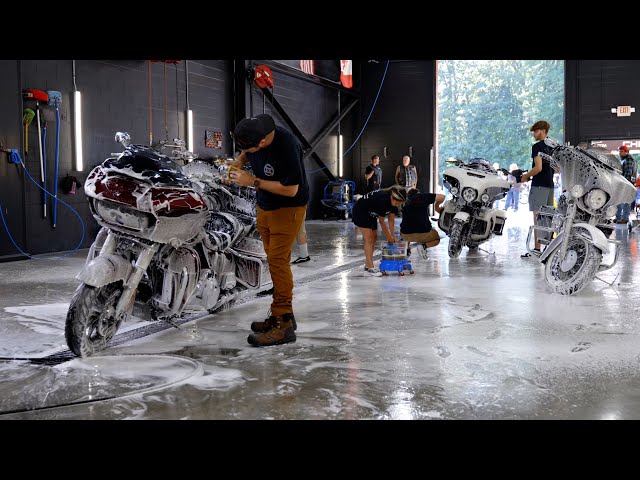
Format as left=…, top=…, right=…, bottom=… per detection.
left=0, top=209, right=640, bottom=419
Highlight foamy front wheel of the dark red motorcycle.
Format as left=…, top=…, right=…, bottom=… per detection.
left=64, top=282, right=123, bottom=357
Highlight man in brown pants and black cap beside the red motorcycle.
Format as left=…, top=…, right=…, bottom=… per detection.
left=229, top=114, right=309, bottom=347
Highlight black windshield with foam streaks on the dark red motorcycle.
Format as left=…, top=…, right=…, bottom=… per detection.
left=102, top=145, right=192, bottom=188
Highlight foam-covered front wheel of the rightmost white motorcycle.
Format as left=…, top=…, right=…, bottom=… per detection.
left=544, top=235, right=602, bottom=295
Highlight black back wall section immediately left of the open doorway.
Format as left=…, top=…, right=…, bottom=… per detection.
left=357, top=60, right=435, bottom=193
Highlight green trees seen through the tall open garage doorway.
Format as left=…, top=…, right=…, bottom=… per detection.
left=438, top=60, right=564, bottom=185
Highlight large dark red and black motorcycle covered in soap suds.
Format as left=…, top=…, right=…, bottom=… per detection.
left=65, top=132, right=272, bottom=357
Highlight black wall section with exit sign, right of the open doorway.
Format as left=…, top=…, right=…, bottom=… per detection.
left=565, top=60, right=640, bottom=144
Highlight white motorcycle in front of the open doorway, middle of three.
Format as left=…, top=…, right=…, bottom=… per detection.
left=438, top=158, right=511, bottom=258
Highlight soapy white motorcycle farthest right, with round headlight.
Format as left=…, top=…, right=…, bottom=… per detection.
left=527, top=138, right=635, bottom=295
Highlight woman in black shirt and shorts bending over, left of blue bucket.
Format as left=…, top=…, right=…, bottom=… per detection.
left=351, top=185, right=407, bottom=277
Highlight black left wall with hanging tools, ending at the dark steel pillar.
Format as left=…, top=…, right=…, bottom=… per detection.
left=0, top=60, right=233, bottom=257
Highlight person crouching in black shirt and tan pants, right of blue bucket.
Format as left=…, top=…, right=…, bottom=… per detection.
left=400, top=188, right=444, bottom=258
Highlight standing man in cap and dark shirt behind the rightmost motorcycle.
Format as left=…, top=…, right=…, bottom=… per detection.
left=520, top=120, right=553, bottom=258
